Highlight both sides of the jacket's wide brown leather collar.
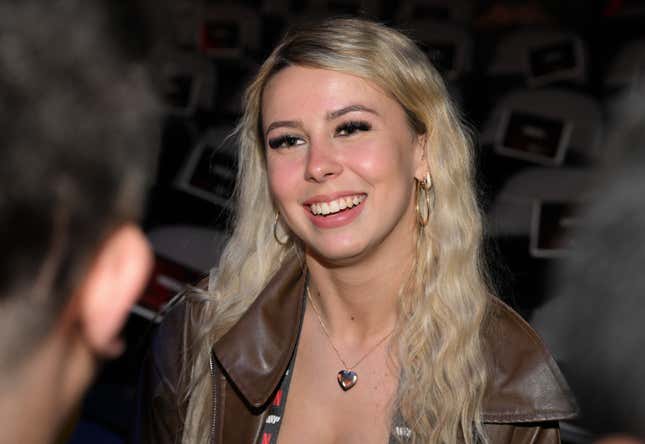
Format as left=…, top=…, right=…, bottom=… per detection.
left=213, top=256, right=577, bottom=423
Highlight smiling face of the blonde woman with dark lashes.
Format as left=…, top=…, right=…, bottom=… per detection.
left=262, top=66, right=426, bottom=263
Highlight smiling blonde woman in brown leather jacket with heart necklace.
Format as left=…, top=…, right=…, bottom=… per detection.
left=141, top=19, right=574, bottom=444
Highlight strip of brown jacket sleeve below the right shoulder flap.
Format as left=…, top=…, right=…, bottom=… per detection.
left=486, top=422, right=560, bottom=444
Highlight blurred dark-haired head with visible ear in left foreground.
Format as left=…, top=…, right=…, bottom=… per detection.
left=0, top=0, right=157, bottom=443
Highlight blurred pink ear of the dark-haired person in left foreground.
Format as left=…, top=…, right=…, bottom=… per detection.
left=78, top=224, right=152, bottom=358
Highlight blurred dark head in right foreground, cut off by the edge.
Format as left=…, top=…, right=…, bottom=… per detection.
left=534, top=86, right=645, bottom=443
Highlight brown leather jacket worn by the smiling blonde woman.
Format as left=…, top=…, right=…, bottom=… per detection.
left=135, top=256, right=576, bottom=444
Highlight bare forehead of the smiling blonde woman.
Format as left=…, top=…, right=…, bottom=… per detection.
left=262, top=66, right=392, bottom=122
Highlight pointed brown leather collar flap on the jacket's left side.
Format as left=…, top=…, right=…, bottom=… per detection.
left=213, top=255, right=306, bottom=408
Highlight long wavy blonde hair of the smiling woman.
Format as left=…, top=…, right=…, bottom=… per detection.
left=183, top=19, right=490, bottom=443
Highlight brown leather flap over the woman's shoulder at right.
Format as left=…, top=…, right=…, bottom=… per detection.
left=482, top=297, right=578, bottom=423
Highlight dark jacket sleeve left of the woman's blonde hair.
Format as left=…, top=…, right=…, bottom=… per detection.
left=130, top=304, right=185, bottom=444
